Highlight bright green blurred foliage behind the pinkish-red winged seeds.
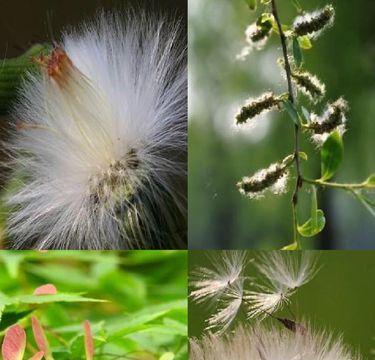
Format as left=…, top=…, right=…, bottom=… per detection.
left=0, top=250, right=187, bottom=360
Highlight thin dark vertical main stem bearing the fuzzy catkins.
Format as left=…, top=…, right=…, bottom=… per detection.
left=271, top=0, right=302, bottom=249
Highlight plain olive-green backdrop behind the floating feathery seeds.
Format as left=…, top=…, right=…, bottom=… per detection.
left=189, top=250, right=375, bottom=359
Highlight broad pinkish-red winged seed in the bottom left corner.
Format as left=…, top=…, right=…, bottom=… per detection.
left=1, top=324, right=26, bottom=360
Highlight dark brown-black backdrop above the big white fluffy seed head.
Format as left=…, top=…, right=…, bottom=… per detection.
left=0, top=0, right=187, bottom=58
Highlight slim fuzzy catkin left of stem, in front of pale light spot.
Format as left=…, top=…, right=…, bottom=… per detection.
left=236, top=92, right=281, bottom=125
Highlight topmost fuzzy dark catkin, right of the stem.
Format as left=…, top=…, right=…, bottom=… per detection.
left=293, top=5, right=335, bottom=38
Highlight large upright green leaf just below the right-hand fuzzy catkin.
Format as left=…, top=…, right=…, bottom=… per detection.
left=320, top=130, right=344, bottom=181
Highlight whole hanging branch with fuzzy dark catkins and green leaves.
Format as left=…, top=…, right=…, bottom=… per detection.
left=236, top=0, right=375, bottom=250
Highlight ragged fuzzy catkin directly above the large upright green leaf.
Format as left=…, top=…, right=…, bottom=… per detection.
left=308, top=97, right=349, bottom=145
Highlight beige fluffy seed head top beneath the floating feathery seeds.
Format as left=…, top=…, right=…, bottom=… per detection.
left=190, top=325, right=360, bottom=360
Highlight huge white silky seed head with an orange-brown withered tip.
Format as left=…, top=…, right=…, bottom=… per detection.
left=8, top=13, right=186, bottom=249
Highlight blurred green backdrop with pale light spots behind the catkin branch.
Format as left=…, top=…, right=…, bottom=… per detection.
left=189, top=0, right=375, bottom=249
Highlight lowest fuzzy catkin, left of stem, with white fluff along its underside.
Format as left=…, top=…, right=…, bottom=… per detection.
left=237, top=163, right=289, bottom=199
